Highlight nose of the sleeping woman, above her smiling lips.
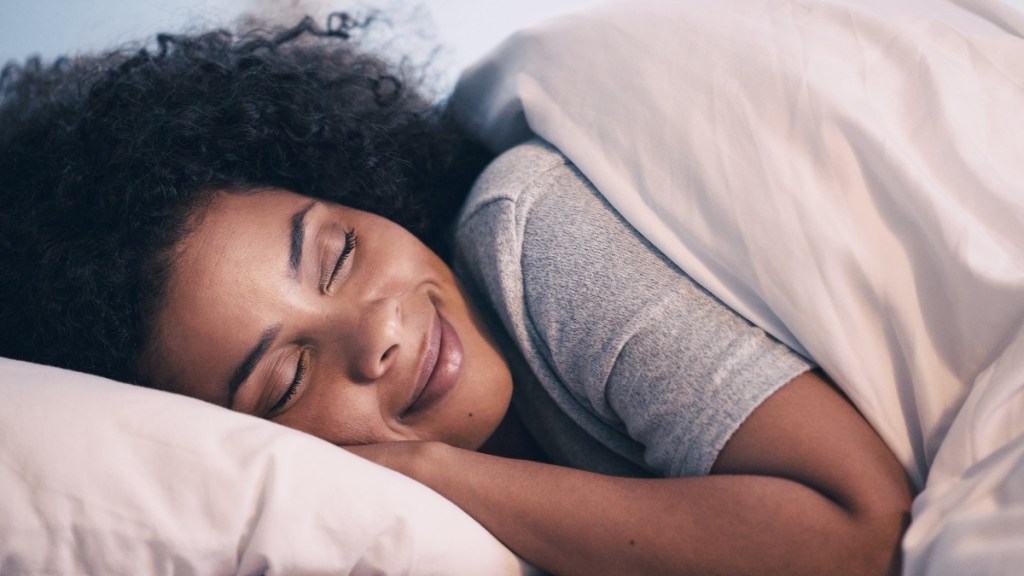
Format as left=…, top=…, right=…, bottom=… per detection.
left=346, top=297, right=403, bottom=383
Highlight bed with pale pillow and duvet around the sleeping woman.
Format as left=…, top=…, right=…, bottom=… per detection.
left=0, top=0, right=1024, bottom=576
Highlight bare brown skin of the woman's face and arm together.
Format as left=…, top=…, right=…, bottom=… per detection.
left=148, top=190, right=912, bottom=576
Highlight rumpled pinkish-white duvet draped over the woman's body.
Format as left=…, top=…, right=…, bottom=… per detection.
left=453, top=0, right=1024, bottom=576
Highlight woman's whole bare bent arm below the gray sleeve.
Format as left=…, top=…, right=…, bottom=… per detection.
left=357, top=373, right=911, bottom=575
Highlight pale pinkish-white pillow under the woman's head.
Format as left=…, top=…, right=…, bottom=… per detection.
left=0, top=359, right=532, bottom=576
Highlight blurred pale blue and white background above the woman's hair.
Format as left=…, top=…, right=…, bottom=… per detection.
left=0, top=0, right=606, bottom=93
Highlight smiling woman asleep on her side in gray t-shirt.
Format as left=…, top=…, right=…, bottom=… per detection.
left=0, top=12, right=912, bottom=575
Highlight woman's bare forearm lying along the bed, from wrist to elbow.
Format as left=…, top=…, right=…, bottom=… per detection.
left=380, top=446, right=902, bottom=575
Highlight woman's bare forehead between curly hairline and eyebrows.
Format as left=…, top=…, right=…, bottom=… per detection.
left=147, top=191, right=310, bottom=404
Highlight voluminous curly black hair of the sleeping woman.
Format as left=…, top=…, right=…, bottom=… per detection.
left=0, top=14, right=487, bottom=384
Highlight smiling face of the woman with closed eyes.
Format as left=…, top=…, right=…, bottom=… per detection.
left=143, top=190, right=512, bottom=449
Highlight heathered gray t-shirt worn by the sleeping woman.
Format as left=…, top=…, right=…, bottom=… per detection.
left=456, top=141, right=809, bottom=477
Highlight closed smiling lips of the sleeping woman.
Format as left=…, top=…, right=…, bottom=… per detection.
left=401, top=307, right=465, bottom=417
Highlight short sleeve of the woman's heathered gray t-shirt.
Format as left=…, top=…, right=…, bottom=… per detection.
left=521, top=142, right=808, bottom=476
